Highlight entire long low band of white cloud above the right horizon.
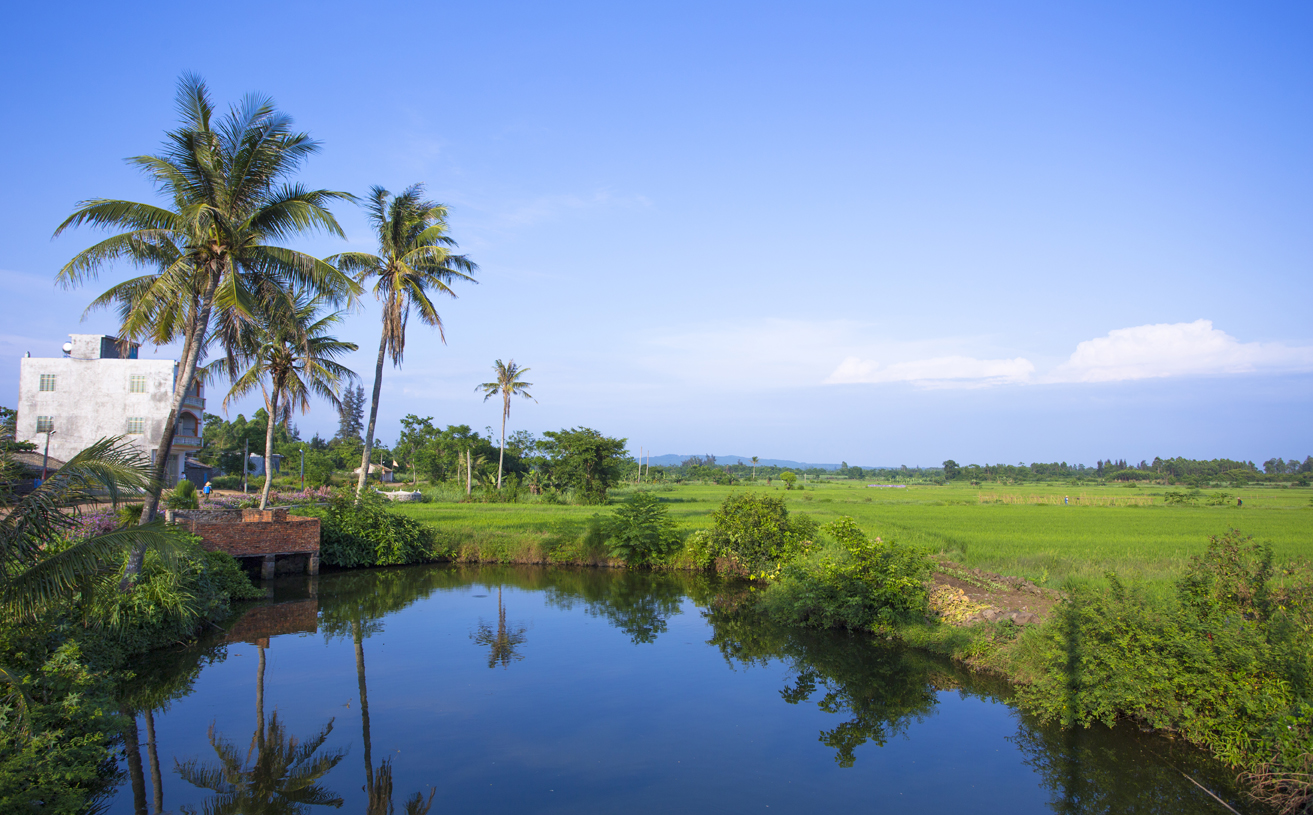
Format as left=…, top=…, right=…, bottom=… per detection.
left=823, top=319, right=1313, bottom=387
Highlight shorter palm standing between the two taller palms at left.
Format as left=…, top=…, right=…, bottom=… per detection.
left=223, top=290, right=357, bottom=509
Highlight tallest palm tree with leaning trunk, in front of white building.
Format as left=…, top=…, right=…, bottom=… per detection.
left=55, top=75, right=358, bottom=588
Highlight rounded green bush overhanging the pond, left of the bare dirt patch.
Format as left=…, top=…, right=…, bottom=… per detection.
left=763, top=517, right=934, bottom=630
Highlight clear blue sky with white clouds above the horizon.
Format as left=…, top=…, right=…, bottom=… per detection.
left=0, top=3, right=1313, bottom=465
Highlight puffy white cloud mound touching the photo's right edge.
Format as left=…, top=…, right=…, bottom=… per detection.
left=1043, top=320, right=1313, bottom=382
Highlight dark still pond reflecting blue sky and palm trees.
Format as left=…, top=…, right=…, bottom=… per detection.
left=108, top=566, right=1257, bottom=815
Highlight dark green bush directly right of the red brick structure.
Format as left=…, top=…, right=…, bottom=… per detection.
left=298, top=488, right=436, bottom=568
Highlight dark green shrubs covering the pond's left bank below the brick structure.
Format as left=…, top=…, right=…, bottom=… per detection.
left=0, top=535, right=263, bottom=815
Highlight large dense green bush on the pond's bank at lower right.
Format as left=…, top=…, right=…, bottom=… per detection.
left=1020, top=530, right=1313, bottom=802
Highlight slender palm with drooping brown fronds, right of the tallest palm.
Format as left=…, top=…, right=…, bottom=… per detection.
left=327, top=184, right=478, bottom=495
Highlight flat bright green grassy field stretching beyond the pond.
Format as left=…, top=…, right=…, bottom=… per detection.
left=399, top=480, right=1313, bottom=588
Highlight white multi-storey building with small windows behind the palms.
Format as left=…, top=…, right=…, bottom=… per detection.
left=16, top=333, right=205, bottom=484
